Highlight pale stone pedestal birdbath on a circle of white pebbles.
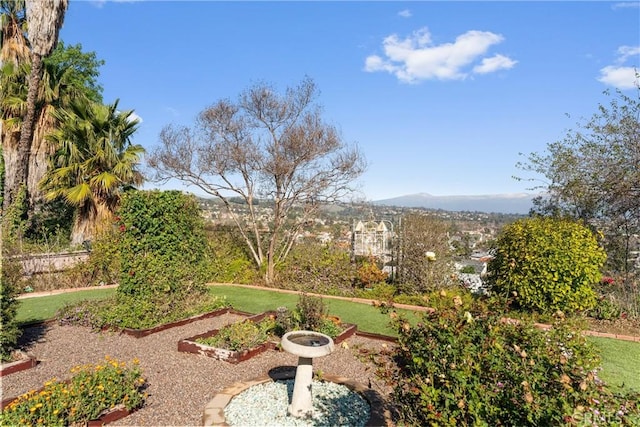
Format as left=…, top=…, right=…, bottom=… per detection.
left=281, top=331, right=334, bottom=418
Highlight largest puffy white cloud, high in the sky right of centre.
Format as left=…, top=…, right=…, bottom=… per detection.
left=364, top=28, right=517, bottom=83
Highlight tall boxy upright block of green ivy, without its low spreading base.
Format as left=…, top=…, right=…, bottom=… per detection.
left=118, top=191, right=207, bottom=300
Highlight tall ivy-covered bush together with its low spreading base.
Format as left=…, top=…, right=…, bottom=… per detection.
left=57, top=191, right=226, bottom=329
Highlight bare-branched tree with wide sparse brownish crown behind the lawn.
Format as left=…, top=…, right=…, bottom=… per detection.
left=148, top=78, right=365, bottom=283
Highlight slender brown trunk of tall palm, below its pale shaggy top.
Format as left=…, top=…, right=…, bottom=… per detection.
left=10, top=53, right=42, bottom=212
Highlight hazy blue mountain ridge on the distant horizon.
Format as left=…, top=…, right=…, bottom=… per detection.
left=373, top=193, right=537, bottom=214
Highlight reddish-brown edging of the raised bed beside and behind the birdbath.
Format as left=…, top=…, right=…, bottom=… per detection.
left=178, top=311, right=357, bottom=364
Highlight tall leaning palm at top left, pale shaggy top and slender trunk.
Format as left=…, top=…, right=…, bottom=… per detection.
left=9, top=0, right=69, bottom=211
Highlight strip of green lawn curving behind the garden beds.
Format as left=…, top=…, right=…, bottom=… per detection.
left=12, top=285, right=640, bottom=391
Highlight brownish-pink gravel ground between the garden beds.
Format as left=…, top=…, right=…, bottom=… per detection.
left=1, top=314, right=396, bottom=426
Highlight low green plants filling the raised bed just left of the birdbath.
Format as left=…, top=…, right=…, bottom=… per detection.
left=196, top=318, right=276, bottom=351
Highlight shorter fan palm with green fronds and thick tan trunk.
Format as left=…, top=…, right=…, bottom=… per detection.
left=41, top=99, right=144, bottom=244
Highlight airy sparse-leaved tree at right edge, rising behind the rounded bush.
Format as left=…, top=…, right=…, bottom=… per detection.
left=518, top=88, right=640, bottom=272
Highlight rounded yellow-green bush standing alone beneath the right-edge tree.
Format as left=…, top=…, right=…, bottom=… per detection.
left=487, top=217, right=606, bottom=312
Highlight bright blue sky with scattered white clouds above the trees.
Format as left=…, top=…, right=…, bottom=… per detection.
left=60, top=0, right=640, bottom=200
